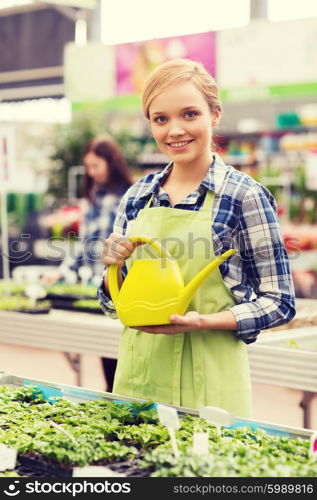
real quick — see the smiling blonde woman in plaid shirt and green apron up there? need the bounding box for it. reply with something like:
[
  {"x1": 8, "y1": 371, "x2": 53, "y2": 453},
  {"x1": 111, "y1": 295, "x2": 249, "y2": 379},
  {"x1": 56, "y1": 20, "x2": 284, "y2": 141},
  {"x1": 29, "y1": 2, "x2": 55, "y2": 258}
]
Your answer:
[{"x1": 98, "y1": 59, "x2": 295, "y2": 417}]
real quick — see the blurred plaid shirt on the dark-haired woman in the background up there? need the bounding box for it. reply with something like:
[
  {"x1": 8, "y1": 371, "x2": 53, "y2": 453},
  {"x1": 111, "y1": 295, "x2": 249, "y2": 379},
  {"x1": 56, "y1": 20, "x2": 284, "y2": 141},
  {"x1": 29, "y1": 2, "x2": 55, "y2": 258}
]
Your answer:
[{"x1": 60, "y1": 188, "x2": 121, "y2": 282}]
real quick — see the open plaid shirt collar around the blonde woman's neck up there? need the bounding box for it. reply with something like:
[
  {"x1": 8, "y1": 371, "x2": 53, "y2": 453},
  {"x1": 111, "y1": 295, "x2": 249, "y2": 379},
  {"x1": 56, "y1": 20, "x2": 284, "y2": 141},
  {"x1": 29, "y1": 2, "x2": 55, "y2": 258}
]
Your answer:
[{"x1": 140, "y1": 153, "x2": 230, "y2": 198}]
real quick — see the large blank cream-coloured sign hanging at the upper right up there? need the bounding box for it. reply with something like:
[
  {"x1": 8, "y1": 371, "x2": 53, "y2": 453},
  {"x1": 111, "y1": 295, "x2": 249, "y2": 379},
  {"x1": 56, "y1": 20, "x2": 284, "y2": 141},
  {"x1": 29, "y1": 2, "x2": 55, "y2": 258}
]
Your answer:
[{"x1": 217, "y1": 19, "x2": 317, "y2": 95}]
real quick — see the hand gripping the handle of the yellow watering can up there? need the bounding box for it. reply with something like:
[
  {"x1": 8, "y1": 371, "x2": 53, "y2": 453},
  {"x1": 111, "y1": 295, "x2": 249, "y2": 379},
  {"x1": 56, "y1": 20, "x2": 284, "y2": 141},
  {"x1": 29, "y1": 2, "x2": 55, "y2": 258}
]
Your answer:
[{"x1": 101, "y1": 233, "x2": 140, "y2": 267}]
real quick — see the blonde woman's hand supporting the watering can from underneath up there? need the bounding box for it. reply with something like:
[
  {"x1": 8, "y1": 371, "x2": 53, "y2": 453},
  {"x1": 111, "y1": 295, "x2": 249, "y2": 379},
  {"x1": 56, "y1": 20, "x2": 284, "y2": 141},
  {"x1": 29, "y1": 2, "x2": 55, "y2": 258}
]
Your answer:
[{"x1": 134, "y1": 311, "x2": 202, "y2": 335}]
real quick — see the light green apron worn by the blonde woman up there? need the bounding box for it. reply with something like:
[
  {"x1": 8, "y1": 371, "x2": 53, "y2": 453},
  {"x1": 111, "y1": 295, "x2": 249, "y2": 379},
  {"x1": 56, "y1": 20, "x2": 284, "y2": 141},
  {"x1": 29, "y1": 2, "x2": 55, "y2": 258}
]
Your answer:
[{"x1": 113, "y1": 191, "x2": 251, "y2": 417}]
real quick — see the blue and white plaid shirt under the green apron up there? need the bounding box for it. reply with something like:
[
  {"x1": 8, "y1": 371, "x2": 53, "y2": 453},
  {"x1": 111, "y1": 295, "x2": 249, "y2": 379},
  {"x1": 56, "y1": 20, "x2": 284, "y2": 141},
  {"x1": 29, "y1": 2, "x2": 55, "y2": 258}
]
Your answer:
[{"x1": 98, "y1": 154, "x2": 295, "y2": 344}]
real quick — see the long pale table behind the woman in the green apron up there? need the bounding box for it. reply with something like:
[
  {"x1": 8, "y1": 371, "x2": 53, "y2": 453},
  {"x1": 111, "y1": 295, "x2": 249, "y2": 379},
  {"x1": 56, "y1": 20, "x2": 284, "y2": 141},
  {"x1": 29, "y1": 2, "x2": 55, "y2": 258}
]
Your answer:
[{"x1": 0, "y1": 301, "x2": 317, "y2": 428}]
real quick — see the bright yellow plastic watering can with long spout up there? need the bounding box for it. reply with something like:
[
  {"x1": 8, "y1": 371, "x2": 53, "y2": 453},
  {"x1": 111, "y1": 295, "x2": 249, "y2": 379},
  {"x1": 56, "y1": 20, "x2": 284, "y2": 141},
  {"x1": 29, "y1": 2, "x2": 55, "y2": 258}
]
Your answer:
[{"x1": 108, "y1": 236, "x2": 237, "y2": 326}]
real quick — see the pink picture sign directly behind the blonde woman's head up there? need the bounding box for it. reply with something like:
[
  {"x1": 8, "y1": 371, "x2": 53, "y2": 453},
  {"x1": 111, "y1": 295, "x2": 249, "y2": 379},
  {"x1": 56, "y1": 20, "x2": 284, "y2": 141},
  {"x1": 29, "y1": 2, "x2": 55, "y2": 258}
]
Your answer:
[{"x1": 115, "y1": 32, "x2": 216, "y2": 95}]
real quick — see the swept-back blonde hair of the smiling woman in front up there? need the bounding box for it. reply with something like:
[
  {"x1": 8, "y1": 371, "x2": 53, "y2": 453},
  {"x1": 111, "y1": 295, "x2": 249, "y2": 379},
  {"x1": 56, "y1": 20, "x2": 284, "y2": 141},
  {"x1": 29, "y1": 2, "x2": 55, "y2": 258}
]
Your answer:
[{"x1": 142, "y1": 59, "x2": 221, "y2": 119}]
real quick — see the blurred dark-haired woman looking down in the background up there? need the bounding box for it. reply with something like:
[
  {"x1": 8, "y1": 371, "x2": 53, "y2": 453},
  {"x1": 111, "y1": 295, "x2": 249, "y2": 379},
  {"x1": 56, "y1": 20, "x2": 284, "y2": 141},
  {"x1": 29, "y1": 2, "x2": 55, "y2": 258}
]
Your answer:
[{"x1": 42, "y1": 135, "x2": 132, "y2": 391}]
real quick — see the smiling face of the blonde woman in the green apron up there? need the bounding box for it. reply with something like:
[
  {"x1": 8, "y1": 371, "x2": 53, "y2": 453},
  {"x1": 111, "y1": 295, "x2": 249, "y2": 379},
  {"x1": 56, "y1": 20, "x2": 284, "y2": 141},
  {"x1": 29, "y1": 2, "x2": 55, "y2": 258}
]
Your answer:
[{"x1": 149, "y1": 81, "x2": 219, "y2": 168}]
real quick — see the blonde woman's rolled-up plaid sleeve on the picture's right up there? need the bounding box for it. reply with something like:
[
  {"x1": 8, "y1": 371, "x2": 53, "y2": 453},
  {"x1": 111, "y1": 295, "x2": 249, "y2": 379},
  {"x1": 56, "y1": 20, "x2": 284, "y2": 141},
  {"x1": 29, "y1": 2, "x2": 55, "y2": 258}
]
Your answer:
[{"x1": 230, "y1": 185, "x2": 296, "y2": 344}]
